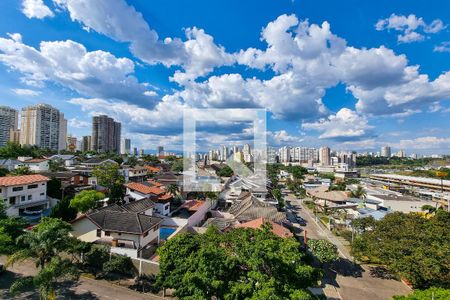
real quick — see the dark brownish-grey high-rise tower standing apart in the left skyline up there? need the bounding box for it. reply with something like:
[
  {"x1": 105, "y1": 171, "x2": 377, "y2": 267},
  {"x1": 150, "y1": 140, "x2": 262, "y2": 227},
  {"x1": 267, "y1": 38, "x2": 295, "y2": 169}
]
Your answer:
[{"x1": 91, "y1": 115, "x2": 121, "y2": 153}]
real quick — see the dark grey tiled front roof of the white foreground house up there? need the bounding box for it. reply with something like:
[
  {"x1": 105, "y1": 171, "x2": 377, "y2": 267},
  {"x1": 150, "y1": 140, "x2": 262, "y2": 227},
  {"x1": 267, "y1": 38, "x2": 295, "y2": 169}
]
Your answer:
[{"x1": 87, "y1": 209, "x2": 162, "y2": 234}]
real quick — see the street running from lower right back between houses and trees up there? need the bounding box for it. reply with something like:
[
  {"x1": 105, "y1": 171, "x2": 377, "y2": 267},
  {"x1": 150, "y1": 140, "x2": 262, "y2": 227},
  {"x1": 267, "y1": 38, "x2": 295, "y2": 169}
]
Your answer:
[{"x1": 286, "y1": 195, "x2": 411, "y2": 300}]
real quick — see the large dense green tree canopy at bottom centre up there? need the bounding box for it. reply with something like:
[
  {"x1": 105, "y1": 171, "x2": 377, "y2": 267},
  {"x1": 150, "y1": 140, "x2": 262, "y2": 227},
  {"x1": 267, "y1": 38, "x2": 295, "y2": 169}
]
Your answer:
[{"x1": 157, "y1": 224, "x2": 320, "y2": 299}]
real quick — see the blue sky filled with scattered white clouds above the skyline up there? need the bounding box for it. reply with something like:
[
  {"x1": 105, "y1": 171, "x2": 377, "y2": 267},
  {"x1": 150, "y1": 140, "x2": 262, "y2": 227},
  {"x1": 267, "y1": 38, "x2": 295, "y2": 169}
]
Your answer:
[{"x1": 0, "y1": 0, "x2": 450, "y2": 154}]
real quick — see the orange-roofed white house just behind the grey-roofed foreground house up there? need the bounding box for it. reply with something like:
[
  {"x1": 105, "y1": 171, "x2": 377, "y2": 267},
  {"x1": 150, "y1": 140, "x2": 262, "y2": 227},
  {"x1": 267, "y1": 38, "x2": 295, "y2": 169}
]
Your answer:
[{"x1": 125, "y1": 182, "x2": 172, "y2": 216}]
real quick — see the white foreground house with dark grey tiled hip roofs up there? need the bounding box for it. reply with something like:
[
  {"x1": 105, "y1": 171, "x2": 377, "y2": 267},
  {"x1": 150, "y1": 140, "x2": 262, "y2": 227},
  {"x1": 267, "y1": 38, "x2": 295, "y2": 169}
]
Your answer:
[{"x1": 71, "y1": 199, "x2": 163, "y2": 258}]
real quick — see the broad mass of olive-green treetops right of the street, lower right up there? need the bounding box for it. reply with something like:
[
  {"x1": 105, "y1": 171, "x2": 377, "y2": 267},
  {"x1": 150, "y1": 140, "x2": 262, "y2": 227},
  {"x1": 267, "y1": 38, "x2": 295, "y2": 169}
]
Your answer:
[{"x1": 352, "y1": 210, "x2": 450, "y2": 288}]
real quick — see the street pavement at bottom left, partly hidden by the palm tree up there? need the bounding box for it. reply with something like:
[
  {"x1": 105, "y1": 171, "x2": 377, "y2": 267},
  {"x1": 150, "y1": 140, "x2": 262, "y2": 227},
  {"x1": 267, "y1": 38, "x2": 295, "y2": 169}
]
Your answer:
[{"x1": 0, "y1": 256, "x2": 167, "y2": 300}]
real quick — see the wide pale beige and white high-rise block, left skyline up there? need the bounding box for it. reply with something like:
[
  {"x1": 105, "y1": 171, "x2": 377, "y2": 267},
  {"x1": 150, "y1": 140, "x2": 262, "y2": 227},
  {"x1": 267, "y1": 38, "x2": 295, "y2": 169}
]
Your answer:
[{"x1": 20, "y1": 104, "x2": 67, "y2": 150}]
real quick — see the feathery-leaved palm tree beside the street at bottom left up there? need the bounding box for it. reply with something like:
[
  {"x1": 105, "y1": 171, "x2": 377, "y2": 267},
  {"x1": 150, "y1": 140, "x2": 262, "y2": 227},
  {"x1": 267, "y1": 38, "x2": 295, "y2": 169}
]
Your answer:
[{"x1": 7, "y1": 217, "x2": 78, "y2": 299}]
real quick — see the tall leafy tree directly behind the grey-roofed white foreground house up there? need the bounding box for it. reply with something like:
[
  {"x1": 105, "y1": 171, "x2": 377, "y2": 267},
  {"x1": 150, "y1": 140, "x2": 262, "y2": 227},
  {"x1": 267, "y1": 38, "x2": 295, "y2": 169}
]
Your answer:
[{"x1": 92, "y1": 163, "x2": 125, "y2": 203}]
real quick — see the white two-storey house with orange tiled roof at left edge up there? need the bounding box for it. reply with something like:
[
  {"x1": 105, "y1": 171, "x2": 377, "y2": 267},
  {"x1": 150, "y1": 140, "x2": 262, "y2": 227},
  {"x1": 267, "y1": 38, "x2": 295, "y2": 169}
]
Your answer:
[{"x1": 0, "y1": 174, "x2": 50, "y2": 216}]
